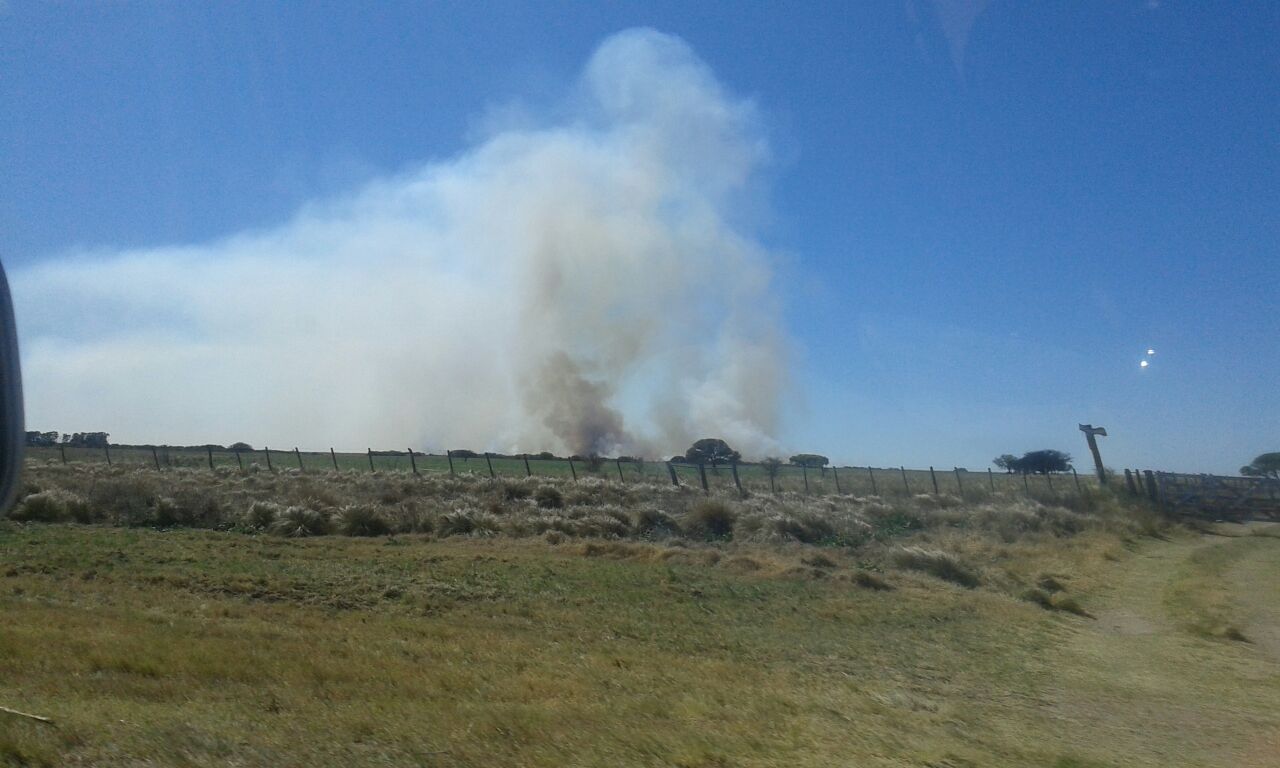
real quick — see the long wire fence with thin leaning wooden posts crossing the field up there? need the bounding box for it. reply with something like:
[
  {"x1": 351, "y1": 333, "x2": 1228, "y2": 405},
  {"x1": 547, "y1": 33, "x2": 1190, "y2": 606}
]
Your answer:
[{"x1": 27, "y1": 444, "x2": 1128, "y2": 499}]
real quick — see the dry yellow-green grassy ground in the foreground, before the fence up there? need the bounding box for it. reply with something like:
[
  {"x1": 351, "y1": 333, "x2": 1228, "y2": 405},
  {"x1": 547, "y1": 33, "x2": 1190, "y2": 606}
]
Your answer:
[{"x1": 0, "y1": 458, "x2": 1280, "y2": 768}]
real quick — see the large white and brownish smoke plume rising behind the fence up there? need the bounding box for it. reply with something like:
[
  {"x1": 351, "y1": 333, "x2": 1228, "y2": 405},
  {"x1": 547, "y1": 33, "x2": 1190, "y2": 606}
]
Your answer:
[{"x1": 13, "y1": 29, "x2": 786, "y2": 456}]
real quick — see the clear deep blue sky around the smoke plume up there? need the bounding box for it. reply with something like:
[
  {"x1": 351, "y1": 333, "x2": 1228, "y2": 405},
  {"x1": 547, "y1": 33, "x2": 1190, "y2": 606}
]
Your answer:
[{"x1": 0, "y1": 0, "x2": 1280, "y2": 471}]
